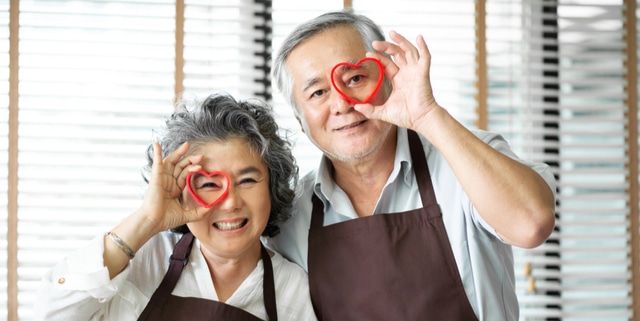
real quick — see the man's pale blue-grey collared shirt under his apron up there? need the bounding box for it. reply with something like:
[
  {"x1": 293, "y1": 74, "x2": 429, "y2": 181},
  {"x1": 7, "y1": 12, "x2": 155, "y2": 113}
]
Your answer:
[{"x1": 267, "y1": 128, "x2": 555, "y2": 321}]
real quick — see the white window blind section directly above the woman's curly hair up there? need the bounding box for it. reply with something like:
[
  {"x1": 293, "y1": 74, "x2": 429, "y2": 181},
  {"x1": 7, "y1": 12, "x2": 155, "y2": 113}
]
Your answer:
[{"x1": 184, "y1": 0, "x2": 265, "y2": 99}]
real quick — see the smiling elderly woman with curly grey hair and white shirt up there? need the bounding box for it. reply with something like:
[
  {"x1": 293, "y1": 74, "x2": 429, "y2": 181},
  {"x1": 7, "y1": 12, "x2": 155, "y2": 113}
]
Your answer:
[{"x1": 35, "y1": 94, "x2": 316, "y2": 321}]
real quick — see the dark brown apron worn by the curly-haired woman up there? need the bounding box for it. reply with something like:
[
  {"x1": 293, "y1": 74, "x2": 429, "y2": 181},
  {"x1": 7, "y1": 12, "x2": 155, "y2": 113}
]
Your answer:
[{"x1": 138, "y1": 233, "x2": 278, "y2": 321}]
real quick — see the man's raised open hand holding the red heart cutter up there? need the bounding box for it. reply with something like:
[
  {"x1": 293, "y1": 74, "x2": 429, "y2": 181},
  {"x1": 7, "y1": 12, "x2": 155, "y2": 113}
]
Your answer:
[{"x1": 355, "y1": 31, "x2": 441, "y2": 130}]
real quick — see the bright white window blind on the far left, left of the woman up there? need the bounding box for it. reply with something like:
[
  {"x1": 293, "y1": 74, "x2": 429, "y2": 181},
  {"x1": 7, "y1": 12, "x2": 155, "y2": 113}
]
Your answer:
[{"x1": 18, "y1": 0, "x2": 175, "y2": 320}]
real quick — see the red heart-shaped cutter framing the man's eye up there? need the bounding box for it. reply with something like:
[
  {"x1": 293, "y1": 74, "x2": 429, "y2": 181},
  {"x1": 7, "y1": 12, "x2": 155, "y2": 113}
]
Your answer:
[{"x1": 331, "y1": 57, "x2": 384, "y2": 104}]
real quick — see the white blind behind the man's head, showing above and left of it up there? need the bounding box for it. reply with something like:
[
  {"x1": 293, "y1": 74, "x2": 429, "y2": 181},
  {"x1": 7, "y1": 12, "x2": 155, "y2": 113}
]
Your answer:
[{"x1": 272, "y1": 0, "x2": 343, "y2": 176}]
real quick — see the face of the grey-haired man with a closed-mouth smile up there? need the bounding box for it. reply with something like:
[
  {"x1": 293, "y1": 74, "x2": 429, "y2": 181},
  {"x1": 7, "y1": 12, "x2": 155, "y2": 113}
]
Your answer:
[{"x1": 286, "y1": 26, "x2": 393, "y2": 162}]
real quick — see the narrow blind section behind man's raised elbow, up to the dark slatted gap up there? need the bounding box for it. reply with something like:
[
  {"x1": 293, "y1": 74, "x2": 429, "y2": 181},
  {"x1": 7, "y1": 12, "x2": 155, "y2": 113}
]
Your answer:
[{"x1": 486, "y1": 0, "x2": 560, "y2": 320}]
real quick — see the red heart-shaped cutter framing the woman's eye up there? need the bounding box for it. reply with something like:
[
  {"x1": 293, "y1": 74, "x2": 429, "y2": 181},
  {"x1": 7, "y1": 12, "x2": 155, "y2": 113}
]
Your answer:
[{"x1": 186, "y1": 170, "x2": 231, "y2": 208}]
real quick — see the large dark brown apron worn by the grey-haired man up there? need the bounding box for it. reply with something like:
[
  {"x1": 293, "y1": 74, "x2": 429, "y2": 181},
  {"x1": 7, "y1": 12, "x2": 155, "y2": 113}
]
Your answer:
[{"x1": 308, "y1": 131, "x2": 478, "y2": 321}]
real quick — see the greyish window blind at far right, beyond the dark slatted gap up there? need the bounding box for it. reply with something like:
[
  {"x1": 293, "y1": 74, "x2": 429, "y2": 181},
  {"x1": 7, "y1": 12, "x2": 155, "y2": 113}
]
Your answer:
[{"x1": 558, "y1": 0, "x2": 632, "y2": 320}]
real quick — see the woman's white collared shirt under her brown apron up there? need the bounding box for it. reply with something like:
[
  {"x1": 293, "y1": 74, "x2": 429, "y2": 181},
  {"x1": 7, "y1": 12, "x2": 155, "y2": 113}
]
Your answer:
[{"x1": 34, "y1": 232, "x2": 316, "y2": 321}]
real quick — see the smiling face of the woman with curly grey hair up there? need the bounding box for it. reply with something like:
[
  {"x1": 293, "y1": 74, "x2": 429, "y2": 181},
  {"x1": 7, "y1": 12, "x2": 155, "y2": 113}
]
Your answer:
[{"x1": 182, "y1": 138, "x2": 271, "y2": 258}]
